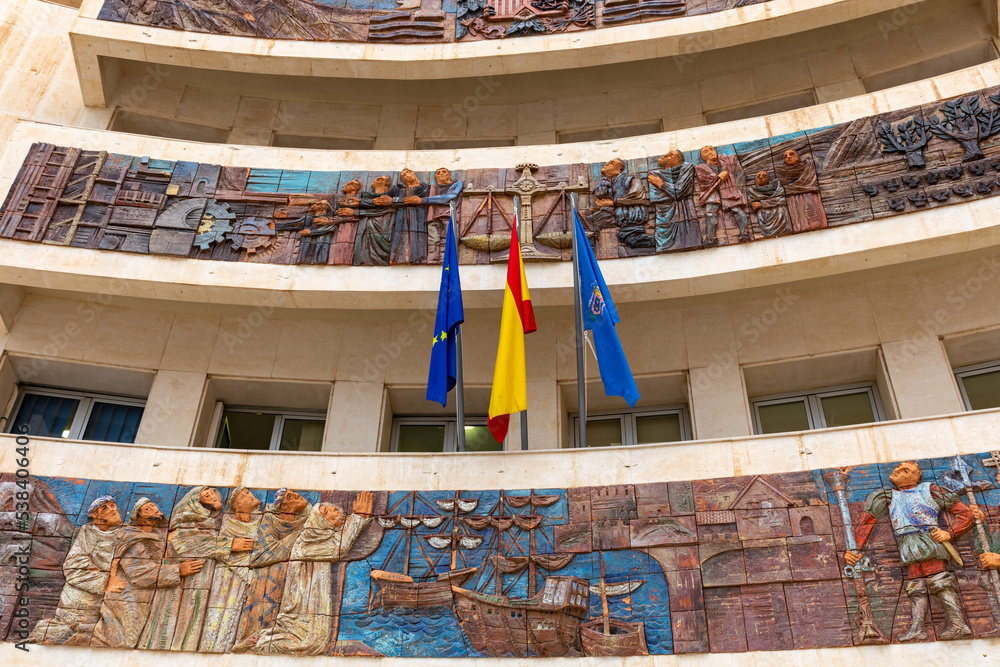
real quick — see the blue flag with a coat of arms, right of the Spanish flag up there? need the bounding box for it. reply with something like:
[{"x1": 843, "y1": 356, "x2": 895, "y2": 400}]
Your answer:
[{"x1": 573, "y1": 210, "x2": 639, "y2": 407}]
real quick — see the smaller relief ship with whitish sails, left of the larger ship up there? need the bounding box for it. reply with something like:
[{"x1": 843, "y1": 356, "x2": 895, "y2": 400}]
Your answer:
[{"x1": 369, "y1": 491, "x2": 483, "y2": 609}]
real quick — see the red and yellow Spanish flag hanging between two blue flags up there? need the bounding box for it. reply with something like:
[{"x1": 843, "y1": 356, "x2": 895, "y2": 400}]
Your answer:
[{"x1": 489, "y1": 214, "x2": 537, "y2": 442}]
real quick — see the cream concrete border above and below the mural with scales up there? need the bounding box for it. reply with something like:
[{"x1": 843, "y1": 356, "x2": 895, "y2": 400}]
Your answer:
[{"x1": 0, "y1": 61, "x2": 1000, "y2": 309}]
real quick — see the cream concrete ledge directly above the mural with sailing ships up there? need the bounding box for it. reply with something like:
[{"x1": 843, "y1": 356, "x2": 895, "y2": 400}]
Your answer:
[{"x1": 0, "y1": 409, "x2": 1000, "y2": 491}]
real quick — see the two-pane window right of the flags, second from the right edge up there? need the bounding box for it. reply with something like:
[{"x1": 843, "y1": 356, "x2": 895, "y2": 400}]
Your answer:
[{"x1": 753, "y1": 384, "x2": 885, "y2": 434}]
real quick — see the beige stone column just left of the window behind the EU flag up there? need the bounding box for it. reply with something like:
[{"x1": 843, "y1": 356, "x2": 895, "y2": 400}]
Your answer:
[{"x1": 323, "y1": 380, "x2": 384, "y2": 453}]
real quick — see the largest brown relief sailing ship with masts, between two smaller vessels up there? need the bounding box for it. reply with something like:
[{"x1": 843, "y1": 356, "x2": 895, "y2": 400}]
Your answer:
[{"x1": 452, "y1": 491, "x2": 590, "y2": 658}]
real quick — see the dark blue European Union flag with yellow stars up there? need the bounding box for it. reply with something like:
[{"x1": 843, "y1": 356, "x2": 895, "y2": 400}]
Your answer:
[{"x1": 427, "y1": 218, "x2": 465, "y2": 406}]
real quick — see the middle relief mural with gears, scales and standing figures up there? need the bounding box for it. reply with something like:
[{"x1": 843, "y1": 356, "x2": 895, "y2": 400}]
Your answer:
[{"x1": 0, "y1": 89, "x2": 1000, "y2": 266}]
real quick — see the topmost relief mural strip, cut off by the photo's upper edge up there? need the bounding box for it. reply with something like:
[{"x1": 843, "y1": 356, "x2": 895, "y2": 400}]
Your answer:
[{"x1": 98, "y1": 0, "x2": 767, "y2": 43}]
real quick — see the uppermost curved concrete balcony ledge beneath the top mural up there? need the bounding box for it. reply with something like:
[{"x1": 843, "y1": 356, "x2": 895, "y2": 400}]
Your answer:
[{"x1": 70, "y1": 0, "x2": 919, "y2": 106}]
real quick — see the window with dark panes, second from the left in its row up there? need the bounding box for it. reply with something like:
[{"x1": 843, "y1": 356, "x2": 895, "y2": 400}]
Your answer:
[{"x1": 215, "y1": 408, "x2": 326, "y2": 452}]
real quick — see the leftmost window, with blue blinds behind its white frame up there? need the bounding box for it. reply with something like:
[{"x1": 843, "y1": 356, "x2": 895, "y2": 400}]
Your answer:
[{"x1": 10, "y1": 387, "x2": 146, "y2": 442}]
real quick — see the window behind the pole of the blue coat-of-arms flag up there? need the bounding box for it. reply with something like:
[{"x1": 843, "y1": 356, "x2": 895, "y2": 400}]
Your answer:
[{"x1": 572, "y1": 408, "x2": 691, "y2": 447}]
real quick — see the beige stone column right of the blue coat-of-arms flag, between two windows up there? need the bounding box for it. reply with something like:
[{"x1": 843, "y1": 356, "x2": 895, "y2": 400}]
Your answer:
[{"x1": 690, "y1": 364, "x2": 753, "y2": 440}]
